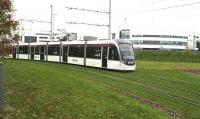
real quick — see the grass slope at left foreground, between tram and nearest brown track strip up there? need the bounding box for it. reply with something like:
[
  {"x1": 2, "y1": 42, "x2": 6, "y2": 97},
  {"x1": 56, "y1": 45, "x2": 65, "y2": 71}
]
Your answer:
[{"x1": 2, "y1": 60, "x2": 171, "y2": 119}]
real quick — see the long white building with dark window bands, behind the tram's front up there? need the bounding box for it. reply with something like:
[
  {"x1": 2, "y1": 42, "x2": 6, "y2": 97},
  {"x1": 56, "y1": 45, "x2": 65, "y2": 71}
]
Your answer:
[{"x1": 120, "y1": 29, "x2": 199, "y2": 50}]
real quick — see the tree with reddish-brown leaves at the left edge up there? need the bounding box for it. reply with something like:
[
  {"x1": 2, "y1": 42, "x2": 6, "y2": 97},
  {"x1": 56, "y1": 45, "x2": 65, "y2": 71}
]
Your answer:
[{"x1": 0, "y1": 0, "x2": 20, "y2": 60}]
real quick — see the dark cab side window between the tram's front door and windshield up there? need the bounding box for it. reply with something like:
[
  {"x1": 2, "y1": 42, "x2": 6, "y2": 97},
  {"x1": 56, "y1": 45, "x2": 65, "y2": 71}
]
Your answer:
[{"x1": 109, "y1": 46, "x2": 119, "y2": 60}]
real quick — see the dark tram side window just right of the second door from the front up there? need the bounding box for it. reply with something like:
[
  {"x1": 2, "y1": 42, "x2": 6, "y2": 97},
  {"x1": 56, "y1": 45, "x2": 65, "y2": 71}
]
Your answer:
[{"x1": 69, "y1": 46, "x2": 84, "y2": 57}]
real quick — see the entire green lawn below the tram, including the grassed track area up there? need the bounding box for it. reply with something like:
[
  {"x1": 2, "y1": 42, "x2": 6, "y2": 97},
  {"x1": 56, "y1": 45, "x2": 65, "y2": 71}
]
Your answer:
[{"x1": 2, "y1": 60, "x2": 200, "y2": 119}]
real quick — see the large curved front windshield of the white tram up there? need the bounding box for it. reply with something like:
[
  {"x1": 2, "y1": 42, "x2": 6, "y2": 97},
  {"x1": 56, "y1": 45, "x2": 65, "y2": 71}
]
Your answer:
[{"x1": 119, "y1": 44, "x2": 134, "y2": 61}]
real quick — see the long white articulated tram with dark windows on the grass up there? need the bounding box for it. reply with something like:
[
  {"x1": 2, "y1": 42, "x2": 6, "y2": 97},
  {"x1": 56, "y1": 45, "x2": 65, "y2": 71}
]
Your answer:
[{"x1": 11, "y1": 40, "x2": 136, "y2": 71}]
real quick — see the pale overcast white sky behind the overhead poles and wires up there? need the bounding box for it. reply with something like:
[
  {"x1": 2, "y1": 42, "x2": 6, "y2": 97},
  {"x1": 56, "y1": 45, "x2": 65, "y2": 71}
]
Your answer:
[{"x1": 14, "y1": 0, "x2": 200, "y2": 38}]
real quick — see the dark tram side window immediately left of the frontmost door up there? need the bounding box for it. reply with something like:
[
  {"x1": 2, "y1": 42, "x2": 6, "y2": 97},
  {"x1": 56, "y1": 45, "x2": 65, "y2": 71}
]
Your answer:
[{"x1": 86, "y1": 47, "x2": 101, "y2": 59}]
